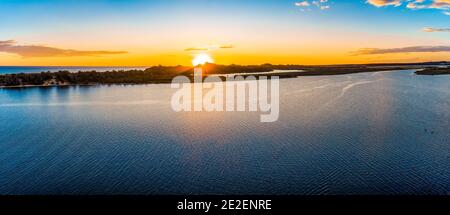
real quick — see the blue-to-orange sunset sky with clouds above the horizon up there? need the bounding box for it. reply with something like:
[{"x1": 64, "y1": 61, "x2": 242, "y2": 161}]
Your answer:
[{"x1": 0, "y1": 0, "x2": 450, "y2": 66}]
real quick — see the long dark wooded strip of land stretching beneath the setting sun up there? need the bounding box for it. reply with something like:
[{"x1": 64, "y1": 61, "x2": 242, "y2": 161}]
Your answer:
[{"x1": 0, "y1": 62, "x2": 450, "y2": 88}]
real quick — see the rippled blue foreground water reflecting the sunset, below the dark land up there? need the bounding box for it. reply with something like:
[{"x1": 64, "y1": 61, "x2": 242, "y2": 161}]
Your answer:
[{"x1": 0, "y1": 71, "x2": 450, "y2": 194}]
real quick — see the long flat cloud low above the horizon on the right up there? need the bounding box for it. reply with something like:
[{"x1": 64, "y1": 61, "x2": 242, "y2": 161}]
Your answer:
[{"x1": 352, "y1": 46, "x2": 450, "y2": 55}]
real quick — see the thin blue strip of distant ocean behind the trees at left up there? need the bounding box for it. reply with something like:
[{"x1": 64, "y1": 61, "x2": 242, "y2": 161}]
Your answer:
[{"x1": 0, "y1": 66, "x2": 148, "y2": 74}]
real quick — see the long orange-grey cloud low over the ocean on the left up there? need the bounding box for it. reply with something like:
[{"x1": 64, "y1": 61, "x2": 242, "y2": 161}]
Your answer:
[{"x1": 0, "y1": 40, "x2": 127, "y2": 57}]
